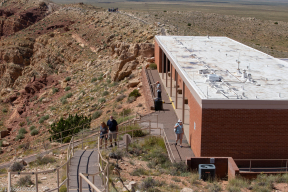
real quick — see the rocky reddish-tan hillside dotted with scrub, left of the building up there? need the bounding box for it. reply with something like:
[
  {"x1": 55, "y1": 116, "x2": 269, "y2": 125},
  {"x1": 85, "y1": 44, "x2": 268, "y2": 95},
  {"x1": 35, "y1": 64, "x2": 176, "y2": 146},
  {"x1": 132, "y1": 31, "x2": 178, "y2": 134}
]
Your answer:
[{"x1": 0, "y1": 1, "x2": 160, "y2": 160}]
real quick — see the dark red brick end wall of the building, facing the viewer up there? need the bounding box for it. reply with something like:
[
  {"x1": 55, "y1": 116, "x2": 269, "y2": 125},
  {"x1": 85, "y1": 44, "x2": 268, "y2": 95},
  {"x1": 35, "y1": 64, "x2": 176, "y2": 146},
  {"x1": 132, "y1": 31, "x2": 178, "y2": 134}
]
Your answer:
[{"x1": 201, "y1": 109, "x2": 288, "y2": 159}]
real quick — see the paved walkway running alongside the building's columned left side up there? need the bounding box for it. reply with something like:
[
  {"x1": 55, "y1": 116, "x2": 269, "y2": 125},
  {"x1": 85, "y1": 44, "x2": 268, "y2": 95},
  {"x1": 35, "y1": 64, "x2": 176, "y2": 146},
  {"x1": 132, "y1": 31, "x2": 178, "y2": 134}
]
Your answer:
[{"x1": 142, "y1": 70, "x2": 195, "y2": 162}]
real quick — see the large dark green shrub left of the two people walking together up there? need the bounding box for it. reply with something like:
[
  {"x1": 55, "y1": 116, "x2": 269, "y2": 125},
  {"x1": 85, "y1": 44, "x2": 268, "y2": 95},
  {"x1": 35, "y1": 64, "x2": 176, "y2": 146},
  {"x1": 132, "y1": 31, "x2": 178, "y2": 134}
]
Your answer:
[{"x1": 49, "y1": 114, "x2": 91, "y2": 140}]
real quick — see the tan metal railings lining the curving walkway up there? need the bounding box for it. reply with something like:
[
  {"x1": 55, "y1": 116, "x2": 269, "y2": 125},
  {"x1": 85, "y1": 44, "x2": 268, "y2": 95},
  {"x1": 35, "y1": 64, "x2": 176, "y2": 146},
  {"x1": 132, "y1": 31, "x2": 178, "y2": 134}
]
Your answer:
[{"x1": 3, "y1": 114, "x2": 175, "y2": 192}]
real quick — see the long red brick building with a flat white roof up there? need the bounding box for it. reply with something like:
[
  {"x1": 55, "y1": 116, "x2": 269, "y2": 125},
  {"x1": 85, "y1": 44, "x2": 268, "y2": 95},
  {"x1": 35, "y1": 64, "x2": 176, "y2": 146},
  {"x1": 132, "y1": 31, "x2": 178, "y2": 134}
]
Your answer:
[{"x1": 155, "y1": 36, "x2": 288, "y2": 159}]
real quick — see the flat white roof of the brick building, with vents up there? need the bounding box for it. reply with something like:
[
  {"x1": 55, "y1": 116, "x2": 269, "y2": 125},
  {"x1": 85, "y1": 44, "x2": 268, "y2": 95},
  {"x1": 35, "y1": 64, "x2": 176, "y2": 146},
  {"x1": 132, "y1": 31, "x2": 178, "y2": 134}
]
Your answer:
[{"x1": 156, "y1": 36, "x2": 288, "y2": 100}]
